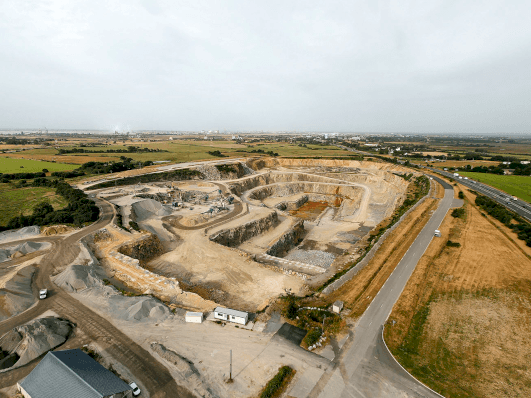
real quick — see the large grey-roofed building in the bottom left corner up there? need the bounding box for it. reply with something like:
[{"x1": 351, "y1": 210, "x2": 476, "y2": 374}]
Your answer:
[{"x1": 18, "y1": 349, "x2": 132, "y2": 398}]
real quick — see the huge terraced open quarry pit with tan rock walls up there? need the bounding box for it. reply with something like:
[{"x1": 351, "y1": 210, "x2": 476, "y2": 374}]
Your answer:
[{"x1": 90, "y1": 158, "x2": 408, "y2": 312}]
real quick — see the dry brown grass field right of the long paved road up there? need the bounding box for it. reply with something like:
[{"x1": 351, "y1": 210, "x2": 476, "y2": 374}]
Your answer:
[{"x1": 385, "y1": 190, "x2": 531, "y2": 398}]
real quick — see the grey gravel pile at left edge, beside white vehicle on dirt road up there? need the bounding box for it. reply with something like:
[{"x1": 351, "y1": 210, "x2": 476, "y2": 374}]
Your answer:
[{"x1": 0, "y1": 265, "x2": 35, "y2": 321}]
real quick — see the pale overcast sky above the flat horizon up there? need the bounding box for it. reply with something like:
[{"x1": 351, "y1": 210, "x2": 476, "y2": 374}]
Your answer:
[{"x1": 0, "y1": 0, "x2": 531, "y2": 133}]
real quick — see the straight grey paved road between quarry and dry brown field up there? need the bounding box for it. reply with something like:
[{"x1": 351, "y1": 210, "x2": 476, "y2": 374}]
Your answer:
[{"x1": 309, "y1": 177, "x2": 454, "y2": 398}]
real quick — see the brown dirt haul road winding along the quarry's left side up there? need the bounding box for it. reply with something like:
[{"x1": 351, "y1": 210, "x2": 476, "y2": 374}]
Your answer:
[{"x1": 0, "y1": 201, "x2": 193, "y2": 398}]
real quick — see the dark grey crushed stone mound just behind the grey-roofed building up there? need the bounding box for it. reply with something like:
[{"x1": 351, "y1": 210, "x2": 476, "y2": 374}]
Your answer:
[{"x1": 0, "y1": 316, "x2": 73, "y2": 369}]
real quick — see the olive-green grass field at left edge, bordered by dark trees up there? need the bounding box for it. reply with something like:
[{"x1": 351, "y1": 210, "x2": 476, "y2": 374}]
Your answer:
[{"x1": 0, "y1": 184, "x2": 68, "y2": 225}]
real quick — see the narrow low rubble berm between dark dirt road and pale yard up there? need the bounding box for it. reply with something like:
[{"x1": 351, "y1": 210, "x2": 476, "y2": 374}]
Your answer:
[{"x1": 151, "y1": 343, "x2": 218, "y2": 398}]
